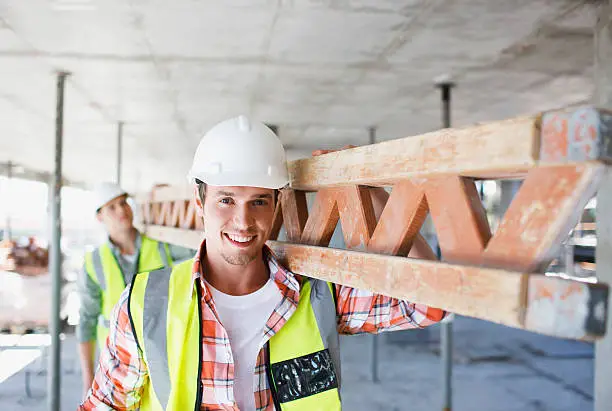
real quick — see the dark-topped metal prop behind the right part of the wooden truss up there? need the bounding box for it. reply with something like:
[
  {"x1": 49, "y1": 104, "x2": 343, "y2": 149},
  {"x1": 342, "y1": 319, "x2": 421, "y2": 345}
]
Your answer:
[{"x1": 436, "y1": 79, "x2": 455, "y2": 411}]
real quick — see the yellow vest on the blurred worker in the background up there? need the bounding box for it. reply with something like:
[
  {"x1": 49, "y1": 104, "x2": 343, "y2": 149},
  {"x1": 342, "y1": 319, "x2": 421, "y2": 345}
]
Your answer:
[{"x1": 85, "y1": 235, "x2": 172, "y2": 348}]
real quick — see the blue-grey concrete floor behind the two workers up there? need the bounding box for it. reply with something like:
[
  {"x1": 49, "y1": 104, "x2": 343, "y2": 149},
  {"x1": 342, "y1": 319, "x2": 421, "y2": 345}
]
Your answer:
[{"x1": 0, "y1": 317, "x2": 593, "y2": 411}]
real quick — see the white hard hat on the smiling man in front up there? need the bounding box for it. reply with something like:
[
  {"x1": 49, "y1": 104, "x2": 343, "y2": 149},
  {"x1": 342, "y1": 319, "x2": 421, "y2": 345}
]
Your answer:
[{"x1": 189, "y1": 116, "x2": 289, "y2": 189}]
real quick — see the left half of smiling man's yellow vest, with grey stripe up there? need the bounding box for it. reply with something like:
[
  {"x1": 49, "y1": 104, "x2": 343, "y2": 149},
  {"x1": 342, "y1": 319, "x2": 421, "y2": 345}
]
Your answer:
[{"x1": 128, "y1": 259, "x2": 202, "y2": 411}]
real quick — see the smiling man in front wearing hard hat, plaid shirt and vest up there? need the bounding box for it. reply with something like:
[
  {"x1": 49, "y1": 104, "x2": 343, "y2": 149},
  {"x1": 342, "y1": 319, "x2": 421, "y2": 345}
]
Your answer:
[{"x1": 79, "y1": 116, "x2": 445, "y2": 411}]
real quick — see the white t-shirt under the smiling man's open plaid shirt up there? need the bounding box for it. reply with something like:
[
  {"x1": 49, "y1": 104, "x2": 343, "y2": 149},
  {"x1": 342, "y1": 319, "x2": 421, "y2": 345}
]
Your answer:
[{"x1": 207, "y1": 279, "x2": 283, "y2": 411}]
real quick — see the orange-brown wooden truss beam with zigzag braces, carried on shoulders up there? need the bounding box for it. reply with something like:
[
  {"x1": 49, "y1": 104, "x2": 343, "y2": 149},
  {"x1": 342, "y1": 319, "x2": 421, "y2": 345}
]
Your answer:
[{"x1": 139, "y1": 107, "x2": 612, "y2": 339}]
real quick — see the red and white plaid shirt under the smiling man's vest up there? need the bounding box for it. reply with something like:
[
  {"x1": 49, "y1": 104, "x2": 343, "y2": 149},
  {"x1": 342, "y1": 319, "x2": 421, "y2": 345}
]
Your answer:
[{"x1": 79, "y1": 243, "x2": 445, "y2": 411}]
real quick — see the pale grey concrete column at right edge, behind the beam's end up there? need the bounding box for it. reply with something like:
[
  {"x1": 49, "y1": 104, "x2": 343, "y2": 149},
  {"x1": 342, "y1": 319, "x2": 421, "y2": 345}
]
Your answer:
[{"x1": 594, "y1": 0, "x2": 612, "y2": 411}]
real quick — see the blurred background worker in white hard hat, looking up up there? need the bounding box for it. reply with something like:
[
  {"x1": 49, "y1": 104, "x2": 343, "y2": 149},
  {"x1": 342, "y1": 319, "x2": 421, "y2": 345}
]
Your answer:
[{"x1": 77, "y1": 183, "x2": 195, "y2": 393}]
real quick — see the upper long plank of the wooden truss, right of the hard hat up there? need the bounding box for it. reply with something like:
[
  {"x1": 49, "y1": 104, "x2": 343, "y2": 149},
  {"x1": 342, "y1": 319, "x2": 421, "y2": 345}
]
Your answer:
[{"x1": 289, "y1": 107, "x2": 612, "y2": 190}]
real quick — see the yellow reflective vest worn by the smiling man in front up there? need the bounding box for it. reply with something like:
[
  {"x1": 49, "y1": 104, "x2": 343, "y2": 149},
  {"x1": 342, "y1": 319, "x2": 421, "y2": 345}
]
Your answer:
[{"x1": 128, "y1": 260, "x2": 341, "y2": 411}]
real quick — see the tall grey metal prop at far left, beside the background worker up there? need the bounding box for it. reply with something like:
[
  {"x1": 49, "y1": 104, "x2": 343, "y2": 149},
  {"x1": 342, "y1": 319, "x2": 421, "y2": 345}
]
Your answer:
[{"x1": 47, "y1": 72, "x2": 68, "y2": 411}]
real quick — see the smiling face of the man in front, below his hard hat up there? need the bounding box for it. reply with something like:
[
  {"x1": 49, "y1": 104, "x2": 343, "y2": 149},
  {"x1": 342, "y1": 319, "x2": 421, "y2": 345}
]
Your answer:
[{"x1": 203, "y1": 185, "x2": 275, "y2": 265}]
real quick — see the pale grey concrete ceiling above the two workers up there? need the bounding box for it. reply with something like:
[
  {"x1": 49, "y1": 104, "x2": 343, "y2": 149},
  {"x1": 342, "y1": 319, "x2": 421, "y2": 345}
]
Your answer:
[{"x1": 0, "y1": 0, "x2": 595, "y2": 189}]
